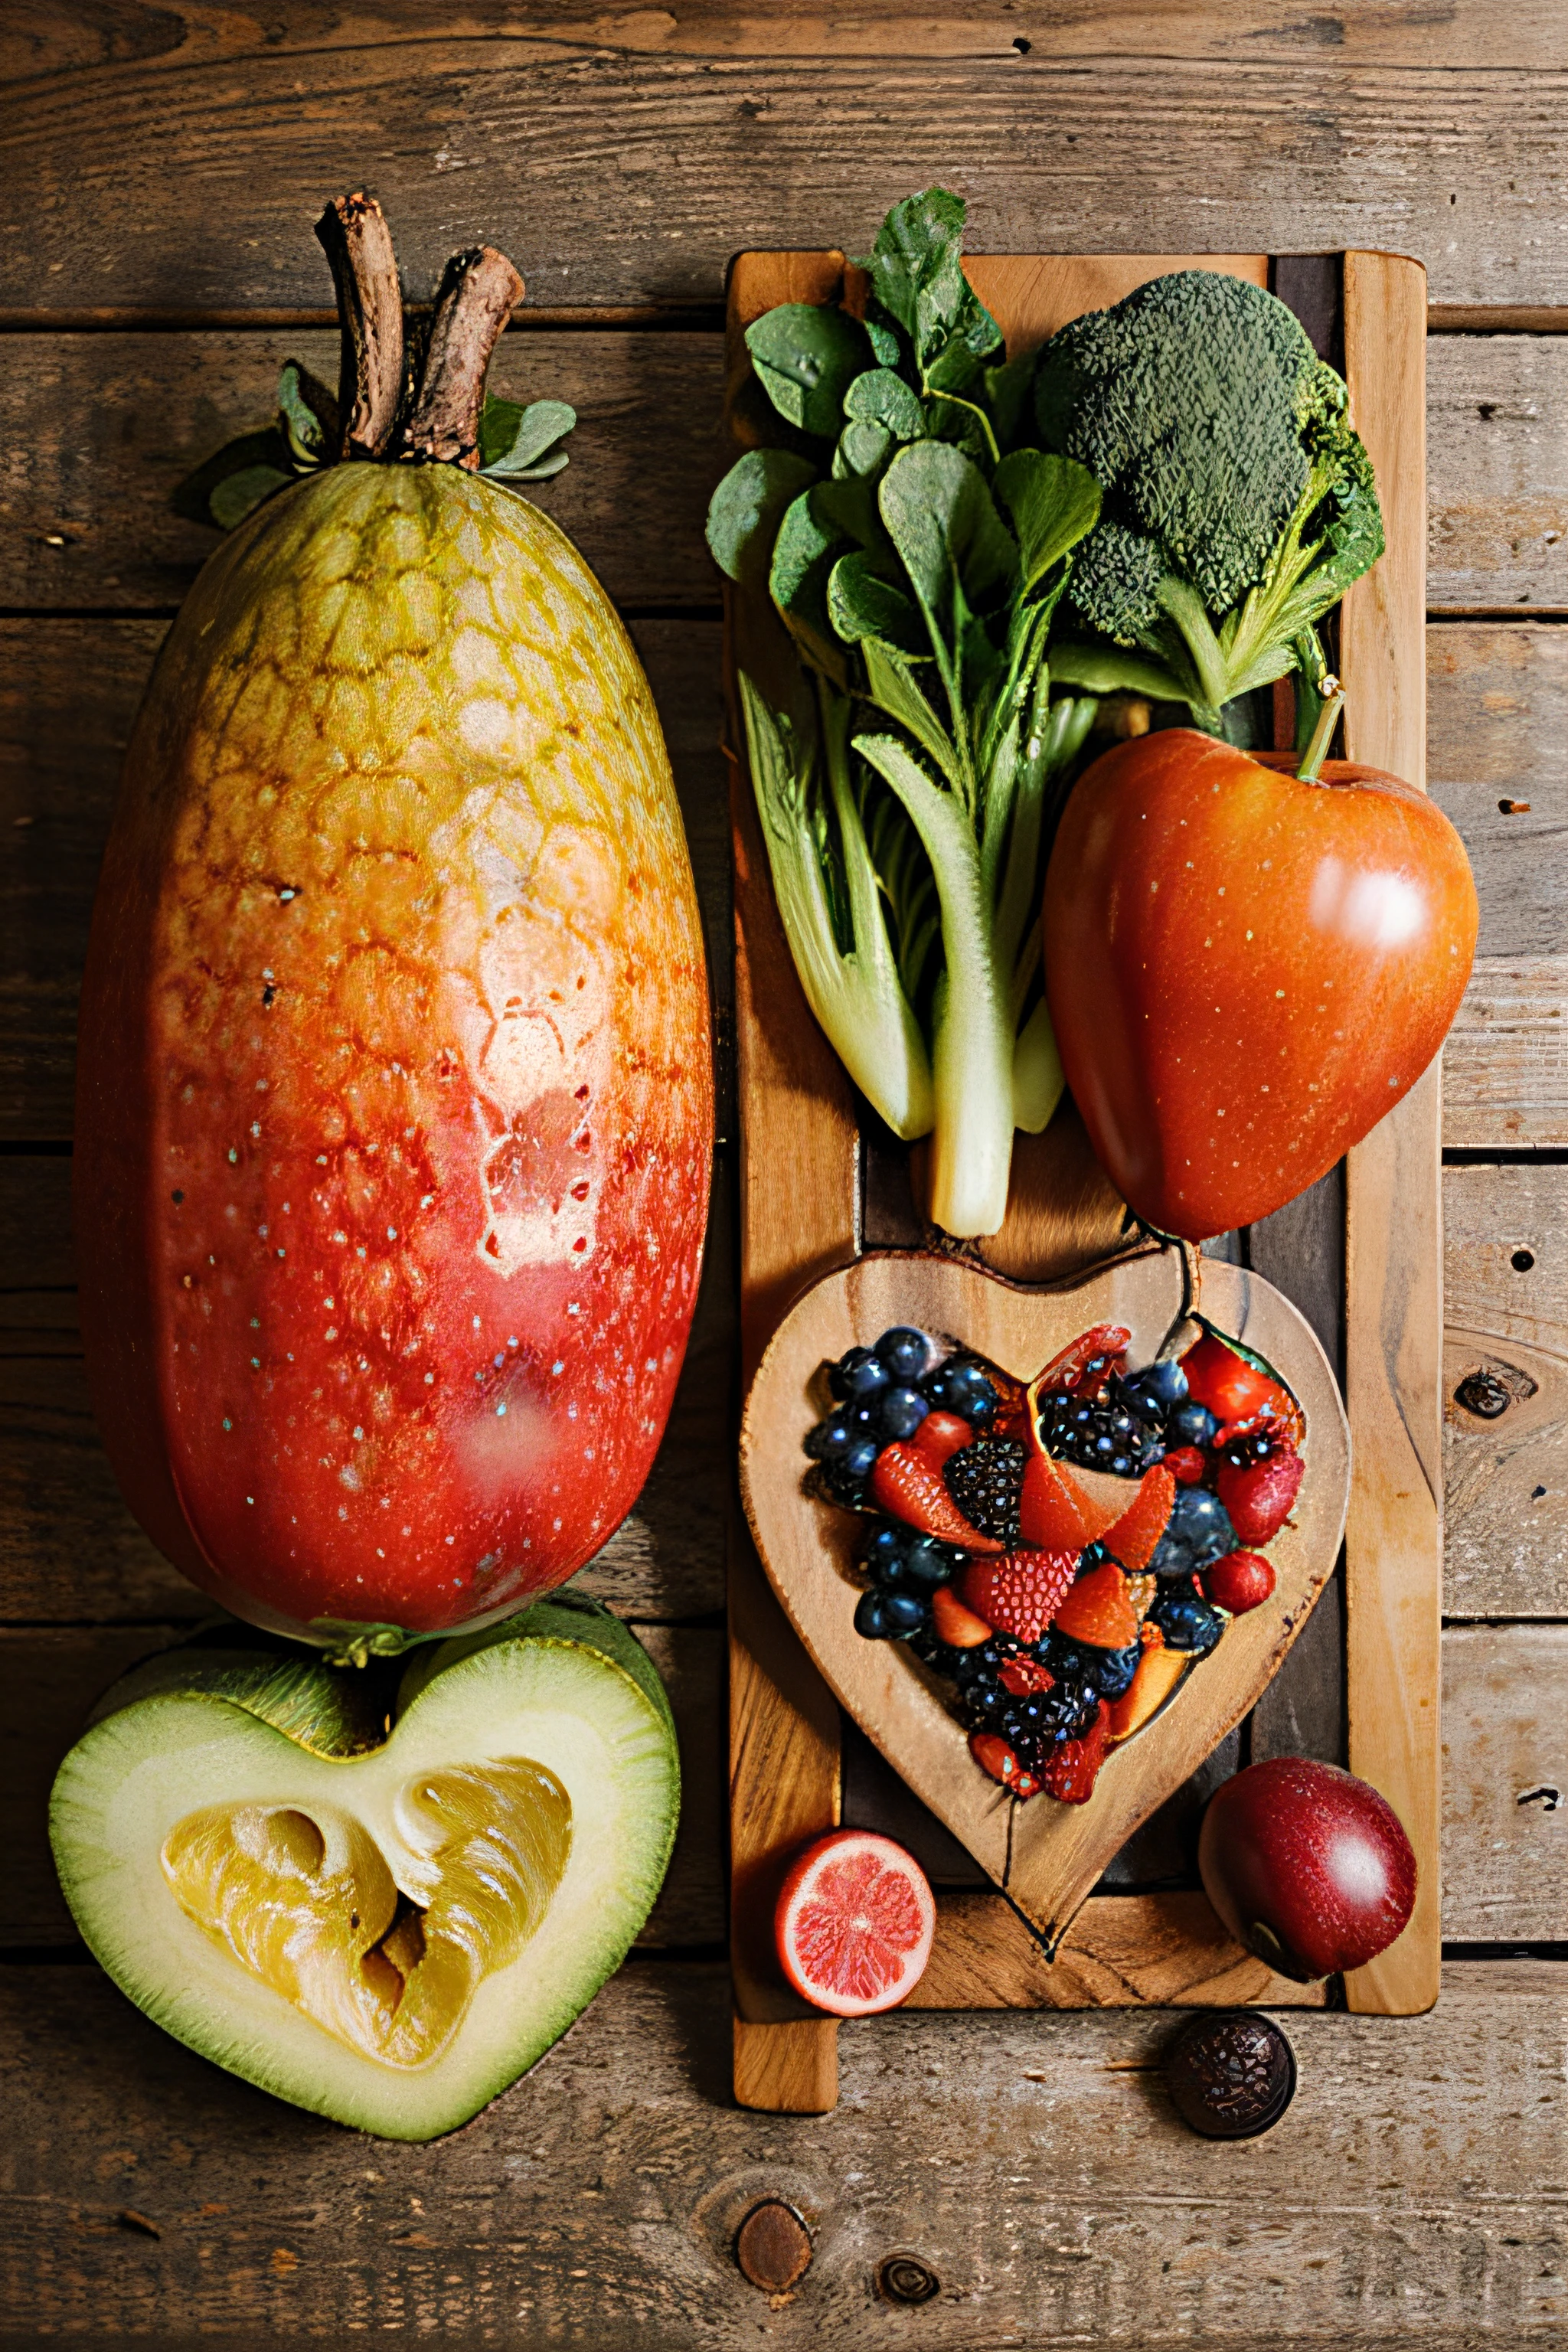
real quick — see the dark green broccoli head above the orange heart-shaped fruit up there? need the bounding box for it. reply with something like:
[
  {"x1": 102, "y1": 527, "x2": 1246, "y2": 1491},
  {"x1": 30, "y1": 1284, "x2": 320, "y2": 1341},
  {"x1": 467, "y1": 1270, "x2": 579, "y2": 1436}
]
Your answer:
[{"x1": 1034, "y1": 270, "x2": 1382, "y2": 724}]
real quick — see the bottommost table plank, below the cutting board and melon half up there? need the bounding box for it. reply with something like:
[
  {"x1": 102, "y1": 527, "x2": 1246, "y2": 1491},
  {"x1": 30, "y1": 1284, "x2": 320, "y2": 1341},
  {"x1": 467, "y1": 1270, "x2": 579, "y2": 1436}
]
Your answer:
[{"x1": 0, "y1": 1962, "x2": 1568, "y2": 2352}]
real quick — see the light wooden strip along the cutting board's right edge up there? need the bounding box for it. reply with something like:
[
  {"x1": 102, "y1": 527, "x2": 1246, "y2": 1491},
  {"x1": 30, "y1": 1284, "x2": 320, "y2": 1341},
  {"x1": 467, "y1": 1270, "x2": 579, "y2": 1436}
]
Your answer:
[{"x1": 1340, "y1": 252, "x2": 1443, "y2": 2016}]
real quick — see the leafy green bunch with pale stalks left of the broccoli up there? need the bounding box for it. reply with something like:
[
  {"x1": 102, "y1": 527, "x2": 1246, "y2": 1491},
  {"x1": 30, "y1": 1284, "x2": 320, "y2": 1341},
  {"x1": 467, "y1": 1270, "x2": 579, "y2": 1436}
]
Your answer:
[{"x1": 707, "y1": 188, "x2": 1100, "y2": 1235}]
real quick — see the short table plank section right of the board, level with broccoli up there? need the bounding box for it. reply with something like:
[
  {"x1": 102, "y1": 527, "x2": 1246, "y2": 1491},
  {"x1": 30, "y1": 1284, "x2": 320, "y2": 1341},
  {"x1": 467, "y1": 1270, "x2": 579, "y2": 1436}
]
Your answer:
[{"x1": 1427, "y1": 343, "x2": 1568, "y2": 612}]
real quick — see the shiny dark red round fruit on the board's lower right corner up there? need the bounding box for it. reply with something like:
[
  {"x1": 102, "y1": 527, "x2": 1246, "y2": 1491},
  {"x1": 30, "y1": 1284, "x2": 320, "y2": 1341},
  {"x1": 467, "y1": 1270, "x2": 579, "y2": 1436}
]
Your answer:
[{"x1": 1204, "y1": 1759, "x2": 1415, "y2": 1985}]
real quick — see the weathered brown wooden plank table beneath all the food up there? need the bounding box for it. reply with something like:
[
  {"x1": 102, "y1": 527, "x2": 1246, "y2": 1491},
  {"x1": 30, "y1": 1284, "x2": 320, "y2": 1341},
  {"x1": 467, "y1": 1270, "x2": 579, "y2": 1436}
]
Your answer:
[{"x1": 0, "y1": 0, "x2": 1568, "y2": 2352}]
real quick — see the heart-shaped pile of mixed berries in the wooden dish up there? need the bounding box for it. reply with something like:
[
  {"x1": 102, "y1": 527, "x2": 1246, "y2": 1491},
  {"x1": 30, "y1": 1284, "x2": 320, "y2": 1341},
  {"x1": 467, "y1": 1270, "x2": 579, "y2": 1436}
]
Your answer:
[{"x1": 806, "y1": 1325, "x2": 1305, "y2": 1804}]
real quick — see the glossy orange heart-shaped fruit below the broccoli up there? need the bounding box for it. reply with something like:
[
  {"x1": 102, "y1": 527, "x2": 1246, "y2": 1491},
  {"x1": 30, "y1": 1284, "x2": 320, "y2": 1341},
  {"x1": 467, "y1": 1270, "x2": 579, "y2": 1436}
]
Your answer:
[{"x1": 1044, "y1": 727, "x2": 1478, "y2": 1240}]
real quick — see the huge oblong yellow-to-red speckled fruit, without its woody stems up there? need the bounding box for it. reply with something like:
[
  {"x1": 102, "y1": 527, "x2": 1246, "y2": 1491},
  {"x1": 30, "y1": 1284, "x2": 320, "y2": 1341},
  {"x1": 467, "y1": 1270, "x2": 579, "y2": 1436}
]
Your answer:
[{"x1": 75, "y1": 463, "x2": 712, "y2": 1632}]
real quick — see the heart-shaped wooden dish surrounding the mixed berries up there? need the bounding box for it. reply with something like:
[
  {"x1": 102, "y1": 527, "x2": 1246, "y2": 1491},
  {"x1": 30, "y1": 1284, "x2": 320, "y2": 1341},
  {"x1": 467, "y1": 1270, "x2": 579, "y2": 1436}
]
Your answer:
[{"x1": 740, "y1": 1244, "x2": 1349, "y2": 1955}]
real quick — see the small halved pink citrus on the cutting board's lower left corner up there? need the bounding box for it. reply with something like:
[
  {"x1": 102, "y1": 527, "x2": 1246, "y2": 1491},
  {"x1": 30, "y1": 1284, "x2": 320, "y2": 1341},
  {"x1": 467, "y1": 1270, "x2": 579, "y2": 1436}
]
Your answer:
[{"x1": 776, "y1": 1830, "x2": 936, "y2": 2018}]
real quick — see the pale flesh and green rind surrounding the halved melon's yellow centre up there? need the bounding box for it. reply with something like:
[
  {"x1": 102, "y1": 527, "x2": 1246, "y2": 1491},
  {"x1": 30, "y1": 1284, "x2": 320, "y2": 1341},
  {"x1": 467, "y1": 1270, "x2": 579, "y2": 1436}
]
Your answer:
[{"x1": 49, "y1": 1602, "x2": 679, "y2": 2141}]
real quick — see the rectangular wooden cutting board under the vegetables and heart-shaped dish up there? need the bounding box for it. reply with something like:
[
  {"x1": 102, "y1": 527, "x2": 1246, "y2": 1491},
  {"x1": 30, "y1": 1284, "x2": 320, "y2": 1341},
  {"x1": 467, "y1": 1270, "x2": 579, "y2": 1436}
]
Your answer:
[{"x1": 727, "y1": 238, "x2": 1441, "y2": 2112}]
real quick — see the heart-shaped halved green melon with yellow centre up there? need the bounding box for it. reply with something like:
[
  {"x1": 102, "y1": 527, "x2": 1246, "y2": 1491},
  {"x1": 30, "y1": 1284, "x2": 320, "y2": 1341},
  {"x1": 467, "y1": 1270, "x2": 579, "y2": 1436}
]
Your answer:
[{"x1": 49, "y1": 1597, "x2": 679, "y2": 2141}]
